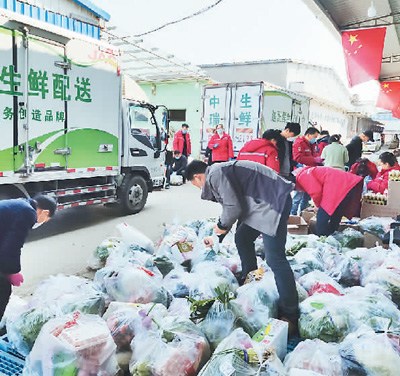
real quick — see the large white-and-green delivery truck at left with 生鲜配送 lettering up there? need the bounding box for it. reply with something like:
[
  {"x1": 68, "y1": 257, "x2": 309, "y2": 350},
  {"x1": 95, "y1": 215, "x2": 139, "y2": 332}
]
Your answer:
[{"x1": 0, "y1": 15, "x2": 168, "y2": 214}]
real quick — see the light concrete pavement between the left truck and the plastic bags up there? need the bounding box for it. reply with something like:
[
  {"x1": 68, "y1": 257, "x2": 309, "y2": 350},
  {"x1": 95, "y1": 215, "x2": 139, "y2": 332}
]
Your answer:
[{"x1": 14, "y1": 183, "x2": 220, "y2": 296}]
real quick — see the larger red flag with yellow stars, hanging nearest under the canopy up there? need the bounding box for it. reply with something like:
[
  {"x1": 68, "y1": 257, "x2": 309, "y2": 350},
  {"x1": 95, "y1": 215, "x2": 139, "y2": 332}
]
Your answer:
[{"x1": 342, "y1": 27, "x2": 386, "y2": 86}]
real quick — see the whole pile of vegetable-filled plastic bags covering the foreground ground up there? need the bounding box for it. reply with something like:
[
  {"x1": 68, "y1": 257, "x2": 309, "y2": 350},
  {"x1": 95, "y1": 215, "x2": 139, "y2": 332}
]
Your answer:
[{"x1": 3, "y1": 218, "x2": 400, "y2": 376}]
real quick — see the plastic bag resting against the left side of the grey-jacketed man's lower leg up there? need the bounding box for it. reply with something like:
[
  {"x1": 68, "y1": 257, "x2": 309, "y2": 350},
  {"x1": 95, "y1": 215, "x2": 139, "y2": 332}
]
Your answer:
[{"x1": 230, "y1": 273, "x2": 279, "y2": 336}]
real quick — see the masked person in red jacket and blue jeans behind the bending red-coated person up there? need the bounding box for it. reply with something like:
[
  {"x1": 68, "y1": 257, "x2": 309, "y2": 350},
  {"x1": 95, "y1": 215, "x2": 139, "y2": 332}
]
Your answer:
[{"x1": 290, "y1": 127, "x2": 322, "y2": 215}]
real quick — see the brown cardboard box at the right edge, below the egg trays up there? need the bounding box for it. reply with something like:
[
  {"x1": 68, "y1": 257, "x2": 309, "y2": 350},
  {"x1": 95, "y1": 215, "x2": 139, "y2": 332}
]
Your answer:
[{"x1": 361, "y1": 180, "x2": 400, "y2": 218}]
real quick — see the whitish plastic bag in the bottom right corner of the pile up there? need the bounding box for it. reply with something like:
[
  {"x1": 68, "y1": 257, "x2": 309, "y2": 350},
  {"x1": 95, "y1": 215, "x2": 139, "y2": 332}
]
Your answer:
[{"x1": 339, "y1": 328, "x2": 400, "y2": 376}]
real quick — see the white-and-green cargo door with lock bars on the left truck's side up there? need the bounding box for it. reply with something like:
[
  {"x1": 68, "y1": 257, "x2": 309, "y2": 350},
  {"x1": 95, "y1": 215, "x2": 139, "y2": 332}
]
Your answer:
[{"x1": 13, "y1": 30, "x2": 70, "y2": 173}]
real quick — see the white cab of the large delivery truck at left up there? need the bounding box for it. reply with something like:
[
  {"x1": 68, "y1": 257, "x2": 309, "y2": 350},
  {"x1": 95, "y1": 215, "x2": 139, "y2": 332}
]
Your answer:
[{"x1": 128, "y1": 103, "x2": 165, "y2": 186}]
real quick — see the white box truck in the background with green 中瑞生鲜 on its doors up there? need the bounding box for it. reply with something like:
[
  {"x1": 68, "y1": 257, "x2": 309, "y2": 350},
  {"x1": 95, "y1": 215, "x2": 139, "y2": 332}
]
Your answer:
[{"x1": 201, "y1": 82, "x2": 310, "y2": 153}]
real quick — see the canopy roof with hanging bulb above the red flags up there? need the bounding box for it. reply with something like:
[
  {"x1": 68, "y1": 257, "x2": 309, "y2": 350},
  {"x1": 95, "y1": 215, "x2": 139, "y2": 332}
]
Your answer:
[{"x1": 303, "y1": 0, "x2": 400, "y2": 81}]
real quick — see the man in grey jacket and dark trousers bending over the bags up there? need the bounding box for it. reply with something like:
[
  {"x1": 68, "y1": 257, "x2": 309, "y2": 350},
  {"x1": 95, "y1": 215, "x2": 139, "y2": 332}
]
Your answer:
[{"x1": 186, "y1": 160, "x2": 299, "y2": 330}]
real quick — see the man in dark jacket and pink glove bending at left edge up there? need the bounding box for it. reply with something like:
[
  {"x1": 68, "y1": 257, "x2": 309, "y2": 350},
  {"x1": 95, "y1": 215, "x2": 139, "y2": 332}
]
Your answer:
[{"x1": 0, "y1": 195, "x2": 56, "y2": 320}]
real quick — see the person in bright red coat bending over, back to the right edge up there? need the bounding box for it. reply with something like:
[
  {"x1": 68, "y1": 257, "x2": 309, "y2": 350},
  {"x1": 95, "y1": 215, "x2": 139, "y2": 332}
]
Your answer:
[{"x1": 293, "y1": 167, "x2": 364, "y2": 236}]
